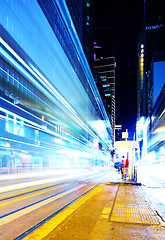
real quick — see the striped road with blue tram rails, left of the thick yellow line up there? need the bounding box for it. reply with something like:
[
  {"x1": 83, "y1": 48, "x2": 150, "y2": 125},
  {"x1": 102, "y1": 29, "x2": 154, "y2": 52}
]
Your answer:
[{"x1": 0, "y1": 169, "x2": 110, "y2": 240}]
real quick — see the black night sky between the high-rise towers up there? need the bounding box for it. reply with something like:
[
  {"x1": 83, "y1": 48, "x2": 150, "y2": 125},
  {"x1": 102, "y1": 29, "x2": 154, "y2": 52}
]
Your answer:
[{"x1": 94, "y1": 0, "x2": 143, "y2": 136}]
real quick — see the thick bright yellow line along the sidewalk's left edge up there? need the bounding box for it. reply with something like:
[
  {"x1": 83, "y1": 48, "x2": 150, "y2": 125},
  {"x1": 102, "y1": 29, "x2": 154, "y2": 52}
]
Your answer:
[{"x1": 23, "y1": 185, "x2": 104, "y2": 240}]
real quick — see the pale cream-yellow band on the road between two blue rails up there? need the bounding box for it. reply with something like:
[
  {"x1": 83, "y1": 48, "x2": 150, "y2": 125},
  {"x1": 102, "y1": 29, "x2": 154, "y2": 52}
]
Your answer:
[{"x1": 0, "y1": 184, "x2": 86, "y2": 226}]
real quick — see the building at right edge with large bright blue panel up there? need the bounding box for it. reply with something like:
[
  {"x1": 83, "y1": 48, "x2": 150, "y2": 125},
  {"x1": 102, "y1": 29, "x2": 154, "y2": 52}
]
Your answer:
[{"x1": 147, "y1": 50, "x2": 165, "y2": 156}]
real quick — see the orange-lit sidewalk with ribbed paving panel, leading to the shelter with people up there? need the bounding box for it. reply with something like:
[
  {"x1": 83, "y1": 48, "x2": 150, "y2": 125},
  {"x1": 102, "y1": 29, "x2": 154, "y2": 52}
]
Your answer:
[{"x1": 27, "y1": 183, "x2": 165, "y2": 240}]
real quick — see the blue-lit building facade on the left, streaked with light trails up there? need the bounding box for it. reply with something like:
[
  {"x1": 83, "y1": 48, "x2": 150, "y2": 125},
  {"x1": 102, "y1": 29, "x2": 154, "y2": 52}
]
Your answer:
[{"x1": 0, "y1": 0, "x2": 112, "y2": 171}]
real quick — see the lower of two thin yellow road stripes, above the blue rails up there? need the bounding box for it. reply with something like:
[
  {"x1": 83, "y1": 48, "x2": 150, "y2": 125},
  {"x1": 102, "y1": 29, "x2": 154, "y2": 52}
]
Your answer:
[{"x1": 0, "y1": 184, "x2": 69, "y2": 207}]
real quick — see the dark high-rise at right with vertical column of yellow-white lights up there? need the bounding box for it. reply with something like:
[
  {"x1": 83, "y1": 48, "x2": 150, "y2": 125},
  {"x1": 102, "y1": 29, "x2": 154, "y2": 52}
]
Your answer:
[{"x1": 138, "y1": 0, "x2": 165, "y2": 118}]
